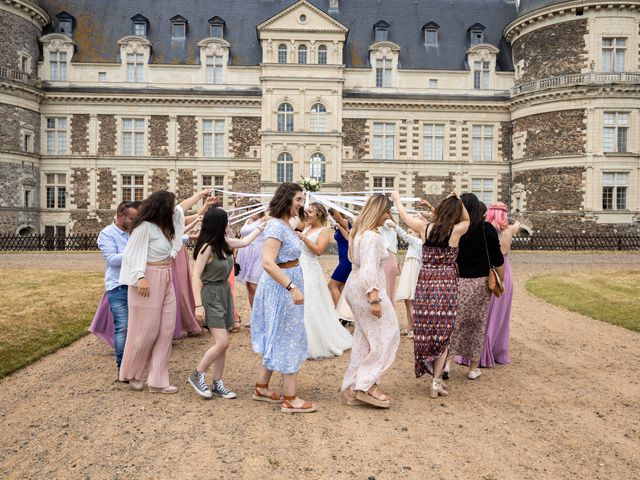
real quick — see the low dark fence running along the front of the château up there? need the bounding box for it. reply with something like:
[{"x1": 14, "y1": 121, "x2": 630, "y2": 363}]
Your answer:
[{"x1": 0, "y1": 233, "x2": 640, "y2": 253}]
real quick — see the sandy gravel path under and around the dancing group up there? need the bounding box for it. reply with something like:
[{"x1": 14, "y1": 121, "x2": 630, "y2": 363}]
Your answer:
[{"x1": 0, "y1": 252, "x2": 640, "y2": 480}]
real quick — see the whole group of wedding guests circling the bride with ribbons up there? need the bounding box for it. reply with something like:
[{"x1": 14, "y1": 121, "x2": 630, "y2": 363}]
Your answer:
[{"x1": 92, "y1": 183, "x2": 516, "y2": 413}]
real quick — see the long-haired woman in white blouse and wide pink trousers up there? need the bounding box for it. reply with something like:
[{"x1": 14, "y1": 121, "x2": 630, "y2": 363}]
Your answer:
[{"x1": 120, "y1": 190, "x2": 209, "y2": 393}]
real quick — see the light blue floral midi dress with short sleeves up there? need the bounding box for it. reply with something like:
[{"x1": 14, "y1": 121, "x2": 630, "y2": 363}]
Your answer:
[{"x1": 251, "y1": 218, "x2": 309, "y2": 374}]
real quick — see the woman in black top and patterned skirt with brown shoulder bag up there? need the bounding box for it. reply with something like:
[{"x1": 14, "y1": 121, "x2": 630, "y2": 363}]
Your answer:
[{"x1": 450, "y1": 193, "x2": 504, "y2": 380}]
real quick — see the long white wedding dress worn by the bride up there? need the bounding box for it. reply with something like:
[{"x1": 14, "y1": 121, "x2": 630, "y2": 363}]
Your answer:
[{"x1": 300, "y1": 230, "x2": 353, "y2": 359}]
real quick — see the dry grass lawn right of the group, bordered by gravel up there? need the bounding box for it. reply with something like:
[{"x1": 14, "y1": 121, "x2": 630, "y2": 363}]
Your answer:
[{"x1": 526, "y1": 270, "x2": 640, "y2": 332}]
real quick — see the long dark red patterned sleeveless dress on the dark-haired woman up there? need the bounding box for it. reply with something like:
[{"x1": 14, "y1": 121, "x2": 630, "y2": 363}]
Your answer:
[{"x1": 413, "y1": 240, "x2": 458, "y2": 377}]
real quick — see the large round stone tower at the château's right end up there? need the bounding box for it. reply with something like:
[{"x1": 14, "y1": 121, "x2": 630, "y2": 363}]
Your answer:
[{"x1": 504, "y1": 0, "x2": 640, "y2": 233}]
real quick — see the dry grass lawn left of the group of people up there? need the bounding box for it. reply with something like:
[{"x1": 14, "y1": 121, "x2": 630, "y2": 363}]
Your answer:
[{"x1": 0, "y1": 269, "x2": 103, "y2": 378}]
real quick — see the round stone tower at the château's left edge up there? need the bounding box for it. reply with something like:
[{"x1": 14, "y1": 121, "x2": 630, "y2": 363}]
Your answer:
[{"x1": 0, "y1": 0, "x2": 49, "y2": 235}]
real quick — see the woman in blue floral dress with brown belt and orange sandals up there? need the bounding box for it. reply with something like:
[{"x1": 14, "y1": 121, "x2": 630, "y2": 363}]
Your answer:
[{"x1": 251, "y1": 183, "x2": 318, "y2": 413}]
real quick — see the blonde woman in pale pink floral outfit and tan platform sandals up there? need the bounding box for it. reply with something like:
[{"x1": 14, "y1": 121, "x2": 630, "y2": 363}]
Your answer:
[{"x1": 342, "y1": 194, "x2": 400, "y2": 408}]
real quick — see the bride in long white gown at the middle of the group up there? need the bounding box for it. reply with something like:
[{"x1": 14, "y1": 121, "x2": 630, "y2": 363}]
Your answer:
[{"x1": 298, "y1": 202, "x2": 352, "y2": 359}]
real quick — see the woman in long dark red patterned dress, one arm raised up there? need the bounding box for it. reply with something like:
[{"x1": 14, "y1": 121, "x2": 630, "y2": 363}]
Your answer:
[{"x1": 391, "y1": 192, "x2": 469, "y2": 398}]
